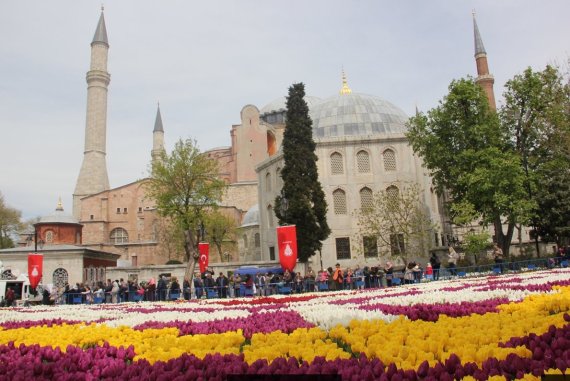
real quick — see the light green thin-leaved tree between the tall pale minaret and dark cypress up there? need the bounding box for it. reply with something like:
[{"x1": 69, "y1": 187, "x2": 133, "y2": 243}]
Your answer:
[{"x1": 146, "y1": 140, "x2": 226, "y2": 280}]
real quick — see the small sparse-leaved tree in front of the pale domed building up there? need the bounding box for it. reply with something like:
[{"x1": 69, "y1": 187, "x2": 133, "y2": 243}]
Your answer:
[{"x1": 354, "y1": 184, "x2": 436, "y2": 260}]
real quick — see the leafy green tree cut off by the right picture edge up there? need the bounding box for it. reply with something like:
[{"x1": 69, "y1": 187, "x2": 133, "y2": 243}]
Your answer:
[{"x1": 499, "y1": 66, "x2": 570, "y2": 243}]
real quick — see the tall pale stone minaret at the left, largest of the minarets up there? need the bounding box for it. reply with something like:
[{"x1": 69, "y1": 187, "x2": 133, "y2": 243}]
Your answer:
[{"x1": 73, "y1": 9, "x2": 111, "y2": 219}]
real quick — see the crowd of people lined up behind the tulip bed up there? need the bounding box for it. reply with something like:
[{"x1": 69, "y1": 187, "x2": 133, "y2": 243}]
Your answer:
[{"x1": 15, "y1": 244, "x2": 570, "y2": 304}]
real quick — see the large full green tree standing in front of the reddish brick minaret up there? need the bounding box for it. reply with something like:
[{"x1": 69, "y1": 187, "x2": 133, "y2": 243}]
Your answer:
[{"x1": 407, "y1": 78, "x2": 536, "y2": 255}]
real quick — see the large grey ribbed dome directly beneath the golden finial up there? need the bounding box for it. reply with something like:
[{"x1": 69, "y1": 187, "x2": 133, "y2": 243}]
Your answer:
[{"x1": 309, "y1": 93, "x2": 408, "y2": 138}]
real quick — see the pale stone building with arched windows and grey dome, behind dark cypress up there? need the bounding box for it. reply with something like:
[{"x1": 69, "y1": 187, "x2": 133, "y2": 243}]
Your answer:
[{"x1": 256, "y1": 78, "x2": 440, "y2": 268}]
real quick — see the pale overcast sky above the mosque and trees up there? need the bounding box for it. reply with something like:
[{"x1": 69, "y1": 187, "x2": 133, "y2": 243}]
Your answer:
[{"x1": 0, "y1": 0, "x2": 570, "y2": 220}]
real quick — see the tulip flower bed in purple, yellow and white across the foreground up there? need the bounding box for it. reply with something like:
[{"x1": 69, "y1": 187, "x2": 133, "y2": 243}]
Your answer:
[{"x1": 0, "y1": 269, "x2": 570, "y2": 380}]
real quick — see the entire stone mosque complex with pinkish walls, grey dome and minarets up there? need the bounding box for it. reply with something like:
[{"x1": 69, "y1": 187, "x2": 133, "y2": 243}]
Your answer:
[{"x1": 64, "y1": 13, "x2": 494, "y2": 267}]
